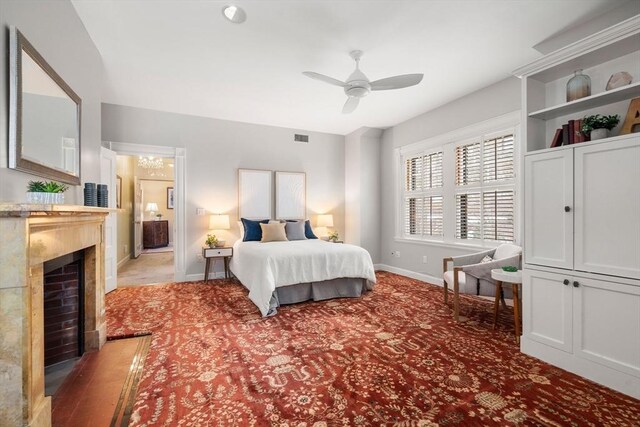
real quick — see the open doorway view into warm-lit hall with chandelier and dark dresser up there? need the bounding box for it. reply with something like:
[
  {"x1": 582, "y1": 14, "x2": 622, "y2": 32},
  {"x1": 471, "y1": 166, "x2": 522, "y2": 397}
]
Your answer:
[{"x1": 116, "y1": 155, "x2": 175, "y2": 287}]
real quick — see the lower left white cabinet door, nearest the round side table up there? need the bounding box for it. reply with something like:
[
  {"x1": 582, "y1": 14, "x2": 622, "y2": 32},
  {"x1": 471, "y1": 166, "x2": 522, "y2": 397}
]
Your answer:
[{"x1": 522, "y1": 269, "x2": 572, "y2": 353}]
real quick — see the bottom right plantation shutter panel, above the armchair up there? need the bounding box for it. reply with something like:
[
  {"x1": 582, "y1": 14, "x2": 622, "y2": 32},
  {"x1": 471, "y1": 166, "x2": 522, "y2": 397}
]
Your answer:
[{"x1": 482, "y1": 190, "x2": 515, "y2": 242}]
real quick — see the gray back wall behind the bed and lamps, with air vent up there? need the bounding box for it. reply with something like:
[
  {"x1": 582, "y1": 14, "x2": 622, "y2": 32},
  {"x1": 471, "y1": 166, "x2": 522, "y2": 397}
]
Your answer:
[{"x1": 102, "y1": 104, "x2": 345, "y2": 275}]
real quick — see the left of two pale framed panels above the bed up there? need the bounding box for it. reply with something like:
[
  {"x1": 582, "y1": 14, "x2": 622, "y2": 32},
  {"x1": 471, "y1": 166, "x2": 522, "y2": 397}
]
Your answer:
[{"x1": 238, "y1": 169, "x2": 273, "y2": 219}]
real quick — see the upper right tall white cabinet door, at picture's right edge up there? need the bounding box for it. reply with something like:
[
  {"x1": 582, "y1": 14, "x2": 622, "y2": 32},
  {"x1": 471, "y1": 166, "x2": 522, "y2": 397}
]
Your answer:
[{"x1": 574, "y1": 140, "x2": 640, "y2": 279}]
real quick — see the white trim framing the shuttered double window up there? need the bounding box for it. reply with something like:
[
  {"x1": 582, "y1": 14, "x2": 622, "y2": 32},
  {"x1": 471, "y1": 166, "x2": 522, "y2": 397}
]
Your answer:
[{"x1": 394, "y1": 110, "x2": 522, "y2": 248}]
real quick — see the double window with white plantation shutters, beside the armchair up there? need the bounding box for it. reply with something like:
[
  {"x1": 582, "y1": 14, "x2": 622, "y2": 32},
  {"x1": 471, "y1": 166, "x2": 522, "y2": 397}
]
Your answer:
[{"x1": 398, "y1": 120, "x2": 516, "y2": 245}]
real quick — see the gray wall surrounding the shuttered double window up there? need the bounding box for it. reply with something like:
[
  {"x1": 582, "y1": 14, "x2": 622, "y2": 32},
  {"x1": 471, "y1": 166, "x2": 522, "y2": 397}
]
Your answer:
[{"x1": 380, "y1": 77, "x2": 520, "y2": 277}]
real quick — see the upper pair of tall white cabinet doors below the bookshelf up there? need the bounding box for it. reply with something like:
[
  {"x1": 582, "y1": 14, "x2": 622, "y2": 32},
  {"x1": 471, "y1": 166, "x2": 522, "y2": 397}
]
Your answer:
[{"x1": 524, "y1": 135, "x2": 640, "y2": 279}]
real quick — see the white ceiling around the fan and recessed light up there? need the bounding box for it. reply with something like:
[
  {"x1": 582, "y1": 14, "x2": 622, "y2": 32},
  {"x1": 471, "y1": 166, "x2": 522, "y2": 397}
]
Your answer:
[{"x1": 72, "y1": 0, "x2": 624, "y2": 135}]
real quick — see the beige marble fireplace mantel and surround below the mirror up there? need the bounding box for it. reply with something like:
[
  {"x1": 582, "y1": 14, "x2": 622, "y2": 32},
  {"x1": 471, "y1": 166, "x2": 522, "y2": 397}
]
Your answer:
[{"x1": 0, "y1": 203, "x2": 111, "y2": 426}]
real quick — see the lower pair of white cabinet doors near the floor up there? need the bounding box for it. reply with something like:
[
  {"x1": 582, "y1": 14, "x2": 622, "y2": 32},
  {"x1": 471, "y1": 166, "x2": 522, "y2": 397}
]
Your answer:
[{"x1": 523, "y1": 269, "x2": 640, "y2": 382}]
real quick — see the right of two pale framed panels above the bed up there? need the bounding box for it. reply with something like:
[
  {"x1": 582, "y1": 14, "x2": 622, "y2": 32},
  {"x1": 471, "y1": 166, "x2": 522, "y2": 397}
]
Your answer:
[{"x1": 276, "y1": 172, "x2": 307, "y2": 219}]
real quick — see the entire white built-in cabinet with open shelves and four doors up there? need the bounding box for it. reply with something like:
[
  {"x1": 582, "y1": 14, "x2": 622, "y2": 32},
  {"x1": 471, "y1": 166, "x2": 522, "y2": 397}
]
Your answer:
[{"x1": 514, "y1": 15, "x2": 640, "y2": 398}]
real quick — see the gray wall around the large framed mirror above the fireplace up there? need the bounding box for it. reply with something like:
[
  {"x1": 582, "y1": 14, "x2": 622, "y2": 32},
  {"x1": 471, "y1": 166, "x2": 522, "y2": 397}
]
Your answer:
[{"x1": 0, "y1": 0, "x2": 102, "y2": 204}]
